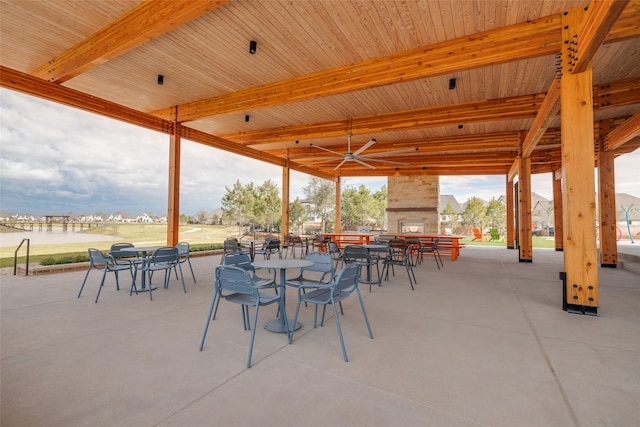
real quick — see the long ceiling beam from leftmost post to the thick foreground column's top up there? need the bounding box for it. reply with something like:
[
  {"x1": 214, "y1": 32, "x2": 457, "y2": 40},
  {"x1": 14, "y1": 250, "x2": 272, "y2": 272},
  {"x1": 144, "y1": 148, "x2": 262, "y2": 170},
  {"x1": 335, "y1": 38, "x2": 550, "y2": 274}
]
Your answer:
[{"x1": 152, "y1": 0, "x2": 640, "y2": 122}]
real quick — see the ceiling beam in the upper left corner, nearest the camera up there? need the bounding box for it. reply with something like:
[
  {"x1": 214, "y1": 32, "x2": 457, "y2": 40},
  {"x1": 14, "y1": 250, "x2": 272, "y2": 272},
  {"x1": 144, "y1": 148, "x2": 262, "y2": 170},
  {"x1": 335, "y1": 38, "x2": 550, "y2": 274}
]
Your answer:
[{"x1": 31, "y1": 0, "x2": 229, "y2": 83}]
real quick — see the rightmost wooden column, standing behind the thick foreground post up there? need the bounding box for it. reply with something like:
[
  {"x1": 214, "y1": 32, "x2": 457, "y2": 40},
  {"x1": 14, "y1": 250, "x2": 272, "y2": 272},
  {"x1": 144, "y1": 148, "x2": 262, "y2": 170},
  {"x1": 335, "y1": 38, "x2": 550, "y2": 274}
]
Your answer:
[{"x1": 598, "y1": 147, "x2": 618, "y2": 268}]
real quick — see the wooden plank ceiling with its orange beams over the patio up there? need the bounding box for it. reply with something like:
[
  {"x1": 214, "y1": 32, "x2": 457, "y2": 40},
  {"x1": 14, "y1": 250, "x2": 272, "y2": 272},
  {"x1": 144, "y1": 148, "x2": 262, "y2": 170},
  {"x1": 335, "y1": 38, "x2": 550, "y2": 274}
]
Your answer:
[{"x1": 0, "y1": 0, "x2": 640, "y2": 178}]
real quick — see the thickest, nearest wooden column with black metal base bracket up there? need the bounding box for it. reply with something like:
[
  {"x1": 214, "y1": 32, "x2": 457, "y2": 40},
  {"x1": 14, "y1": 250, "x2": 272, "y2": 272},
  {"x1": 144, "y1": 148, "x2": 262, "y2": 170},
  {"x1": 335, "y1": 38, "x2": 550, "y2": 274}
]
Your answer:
[{"x1": 560, "y1": 8, "x2": 598, "y2": 314}]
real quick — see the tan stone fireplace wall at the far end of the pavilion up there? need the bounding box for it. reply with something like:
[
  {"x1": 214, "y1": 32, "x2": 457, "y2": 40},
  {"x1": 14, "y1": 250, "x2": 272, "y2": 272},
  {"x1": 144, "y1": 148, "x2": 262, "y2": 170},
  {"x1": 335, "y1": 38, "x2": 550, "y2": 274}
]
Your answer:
[{"x1": 387, "y1": 176, "x2": 440, "y2": 234}]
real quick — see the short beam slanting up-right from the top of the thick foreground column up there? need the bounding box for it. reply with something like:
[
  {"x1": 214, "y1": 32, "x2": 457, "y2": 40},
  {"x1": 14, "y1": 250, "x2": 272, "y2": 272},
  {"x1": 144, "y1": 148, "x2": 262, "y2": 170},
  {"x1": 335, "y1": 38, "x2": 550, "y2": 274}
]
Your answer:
[{"x1": 569, "y1": 0, "x2": 629, "y2": 74}]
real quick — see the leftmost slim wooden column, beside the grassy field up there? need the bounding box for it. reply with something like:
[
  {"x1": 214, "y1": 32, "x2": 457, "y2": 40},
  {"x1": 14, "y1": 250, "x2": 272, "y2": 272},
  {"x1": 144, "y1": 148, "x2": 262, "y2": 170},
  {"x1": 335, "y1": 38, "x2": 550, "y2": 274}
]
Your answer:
[{"x1": 167, "y1": 122, "x2": 181, "y2": 246}]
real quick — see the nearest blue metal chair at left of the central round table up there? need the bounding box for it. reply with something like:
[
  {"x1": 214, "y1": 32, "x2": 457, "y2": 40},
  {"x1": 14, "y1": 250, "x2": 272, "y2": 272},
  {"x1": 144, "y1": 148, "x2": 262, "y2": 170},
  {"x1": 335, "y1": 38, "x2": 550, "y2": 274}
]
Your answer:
[{"x1": 200, "y1": 265, "x2": 290, "y2": 368}]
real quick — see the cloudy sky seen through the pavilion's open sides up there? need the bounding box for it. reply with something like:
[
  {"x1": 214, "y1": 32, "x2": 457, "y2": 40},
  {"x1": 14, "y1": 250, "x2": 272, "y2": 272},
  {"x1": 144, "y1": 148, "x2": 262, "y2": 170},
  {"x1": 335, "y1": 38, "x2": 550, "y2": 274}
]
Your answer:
[{"x1": 0, "y1": 89, "x2": 640, "y2": 215}]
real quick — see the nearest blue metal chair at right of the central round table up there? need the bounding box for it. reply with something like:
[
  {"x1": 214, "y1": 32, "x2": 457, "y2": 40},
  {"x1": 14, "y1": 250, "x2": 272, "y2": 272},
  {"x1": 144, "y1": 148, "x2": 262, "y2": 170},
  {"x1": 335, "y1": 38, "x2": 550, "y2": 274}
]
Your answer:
[{"x1": 289, "y1": 262, "x2": 373, "y2": 362}]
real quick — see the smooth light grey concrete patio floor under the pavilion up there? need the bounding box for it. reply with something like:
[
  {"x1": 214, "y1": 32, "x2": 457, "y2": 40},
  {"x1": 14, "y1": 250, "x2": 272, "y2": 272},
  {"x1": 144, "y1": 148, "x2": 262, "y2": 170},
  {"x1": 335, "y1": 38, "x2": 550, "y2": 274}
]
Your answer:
[{"x1": 0, "y1": 247, "x2": 640, "y2": 427}]
